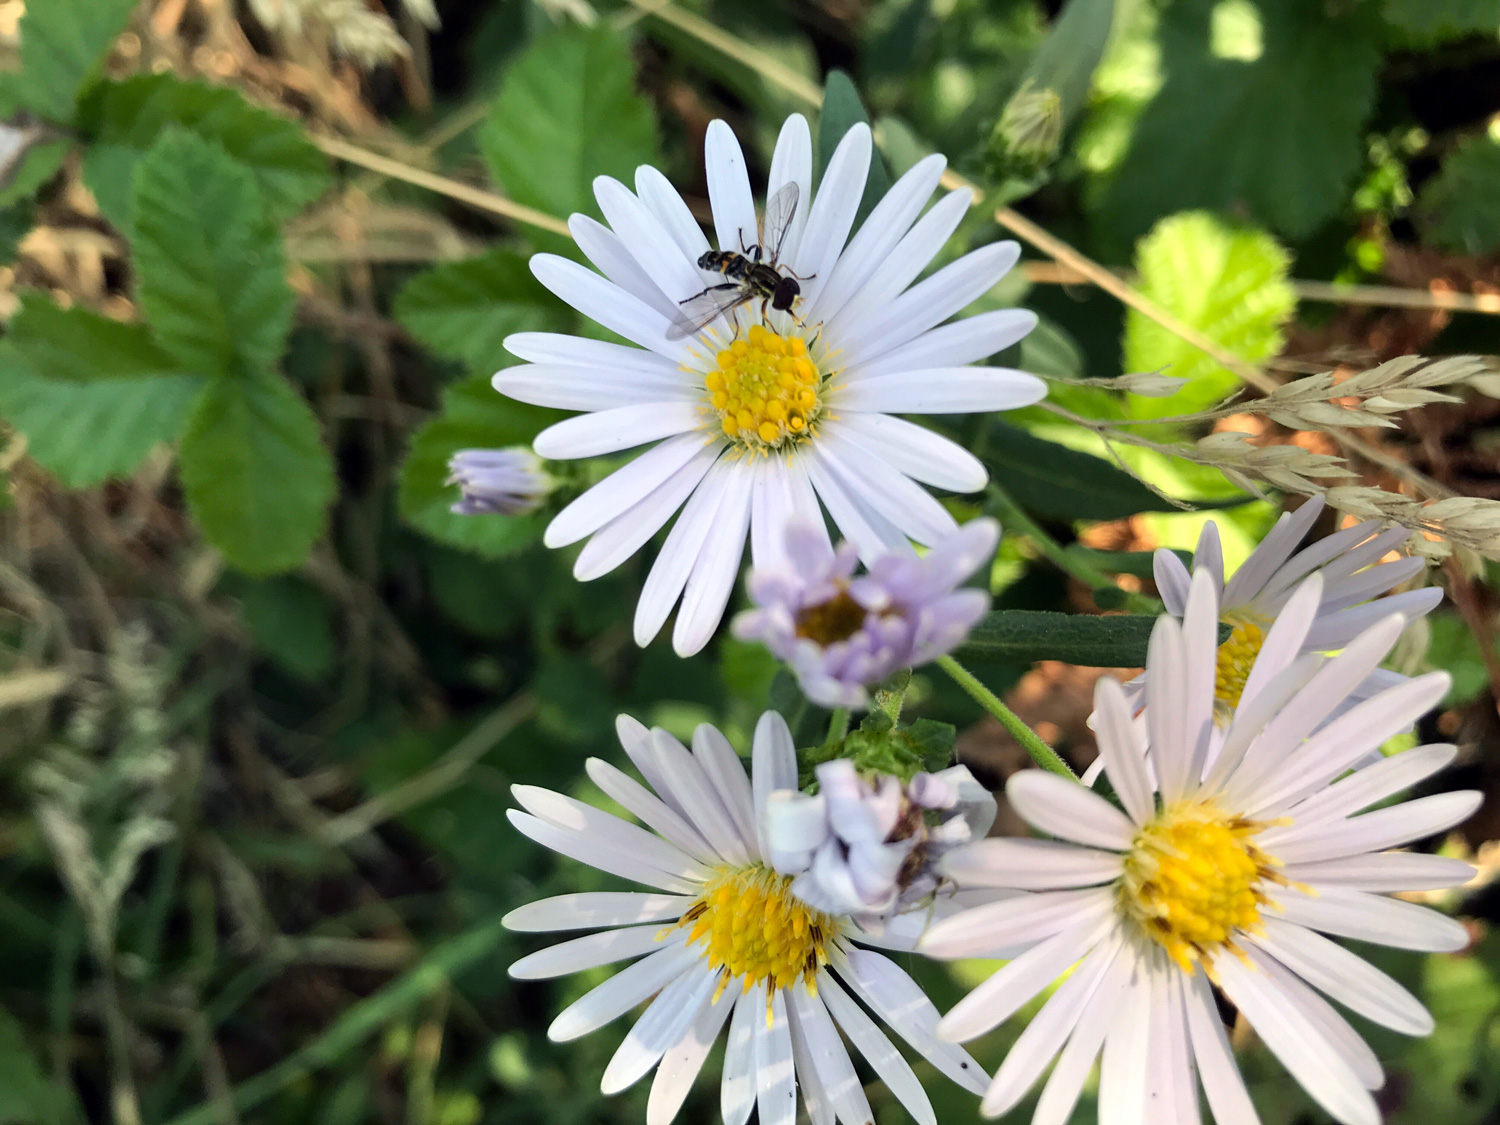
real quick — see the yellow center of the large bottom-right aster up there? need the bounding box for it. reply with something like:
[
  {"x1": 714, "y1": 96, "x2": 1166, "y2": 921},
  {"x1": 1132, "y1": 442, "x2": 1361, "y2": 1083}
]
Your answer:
[{"x1": 1119, "y1": 801, "x2": 1286, "y2": 972}]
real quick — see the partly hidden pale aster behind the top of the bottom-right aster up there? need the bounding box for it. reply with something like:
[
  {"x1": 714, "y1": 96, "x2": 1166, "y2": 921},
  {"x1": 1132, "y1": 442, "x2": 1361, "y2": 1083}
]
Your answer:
[{"x1": 1133, "y1": 497, "x2": 1443, "y2": 723}]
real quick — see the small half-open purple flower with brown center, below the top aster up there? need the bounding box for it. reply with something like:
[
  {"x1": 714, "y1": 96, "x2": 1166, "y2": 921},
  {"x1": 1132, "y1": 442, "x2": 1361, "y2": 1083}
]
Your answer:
[{"x1": 734, "y1": 519, "x2": 1001, "y2": 707}]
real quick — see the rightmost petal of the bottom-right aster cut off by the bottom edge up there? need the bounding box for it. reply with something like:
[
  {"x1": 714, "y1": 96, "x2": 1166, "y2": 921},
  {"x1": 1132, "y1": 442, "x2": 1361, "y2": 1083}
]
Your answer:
[{"x1": 1217, "y1": 957, "x2": 1380, "y2": 1125}]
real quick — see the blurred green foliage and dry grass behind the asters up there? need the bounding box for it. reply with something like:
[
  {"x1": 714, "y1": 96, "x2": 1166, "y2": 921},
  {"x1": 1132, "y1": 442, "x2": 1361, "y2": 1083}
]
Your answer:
[{"x1": 0, "y1": 0, "x2": 1500, "y2": 1125}]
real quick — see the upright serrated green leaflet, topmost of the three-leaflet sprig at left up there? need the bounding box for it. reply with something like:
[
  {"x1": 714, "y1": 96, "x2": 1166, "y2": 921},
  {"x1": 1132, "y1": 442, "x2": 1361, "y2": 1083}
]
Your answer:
[{"x1": 132, "y1": 126, "x2": 296, "y2": 375}]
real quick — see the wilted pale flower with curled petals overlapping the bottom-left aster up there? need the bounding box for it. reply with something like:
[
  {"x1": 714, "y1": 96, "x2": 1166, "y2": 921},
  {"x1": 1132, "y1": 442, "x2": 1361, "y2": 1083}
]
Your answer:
[{"x1": 764, "y1": 758, "x2": 995, "y2": 935}]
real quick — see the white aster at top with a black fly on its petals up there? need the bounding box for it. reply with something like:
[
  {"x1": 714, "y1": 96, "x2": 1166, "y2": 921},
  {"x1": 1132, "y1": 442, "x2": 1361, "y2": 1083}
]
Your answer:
[{"x1": 495, "y1": 116, "x2": 1046, "y2": 656}]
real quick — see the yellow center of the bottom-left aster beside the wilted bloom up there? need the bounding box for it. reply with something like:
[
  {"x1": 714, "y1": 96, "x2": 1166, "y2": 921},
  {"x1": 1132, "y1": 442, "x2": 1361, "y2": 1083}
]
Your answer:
[{"x1": 665, "y1": 864, "x2": 839, "y2": 1020}]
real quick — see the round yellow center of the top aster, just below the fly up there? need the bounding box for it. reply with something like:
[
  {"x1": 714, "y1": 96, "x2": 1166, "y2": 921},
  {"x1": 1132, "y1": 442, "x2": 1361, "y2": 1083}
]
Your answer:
[{"x1": 704, "y1": 324, "x2": 824, "y2": 450}]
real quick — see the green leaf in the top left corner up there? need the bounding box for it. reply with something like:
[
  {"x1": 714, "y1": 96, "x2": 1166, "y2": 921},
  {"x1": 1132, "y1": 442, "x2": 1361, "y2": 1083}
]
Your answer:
[{"x1": 11, "y1": 0, "x2": 140, "y2": 123}]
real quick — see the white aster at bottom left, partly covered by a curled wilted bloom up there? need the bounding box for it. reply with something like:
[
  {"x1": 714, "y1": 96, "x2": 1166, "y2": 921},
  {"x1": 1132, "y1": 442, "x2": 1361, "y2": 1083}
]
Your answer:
[{"x1": 506, "y1": 711, "x2": 986, "y2": 1125}]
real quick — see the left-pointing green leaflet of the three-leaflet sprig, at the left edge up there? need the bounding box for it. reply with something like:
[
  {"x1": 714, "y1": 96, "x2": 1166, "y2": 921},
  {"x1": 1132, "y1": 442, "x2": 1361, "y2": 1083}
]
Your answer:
[{"x1": 0, "y1": 294, "x2": 203, "y2": 488}]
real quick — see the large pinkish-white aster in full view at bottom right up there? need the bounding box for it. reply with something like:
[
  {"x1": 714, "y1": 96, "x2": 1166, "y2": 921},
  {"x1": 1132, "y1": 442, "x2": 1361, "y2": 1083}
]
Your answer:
[{"x1": 920, "y1": 570, "x2": 1481, "y2": 1125}]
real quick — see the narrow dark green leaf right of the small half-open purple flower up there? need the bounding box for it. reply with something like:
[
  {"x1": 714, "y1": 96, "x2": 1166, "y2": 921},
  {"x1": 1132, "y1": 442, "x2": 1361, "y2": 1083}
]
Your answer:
[{"x1": 954, "y1": 609, "x2": 1230, "y2": 668}]
